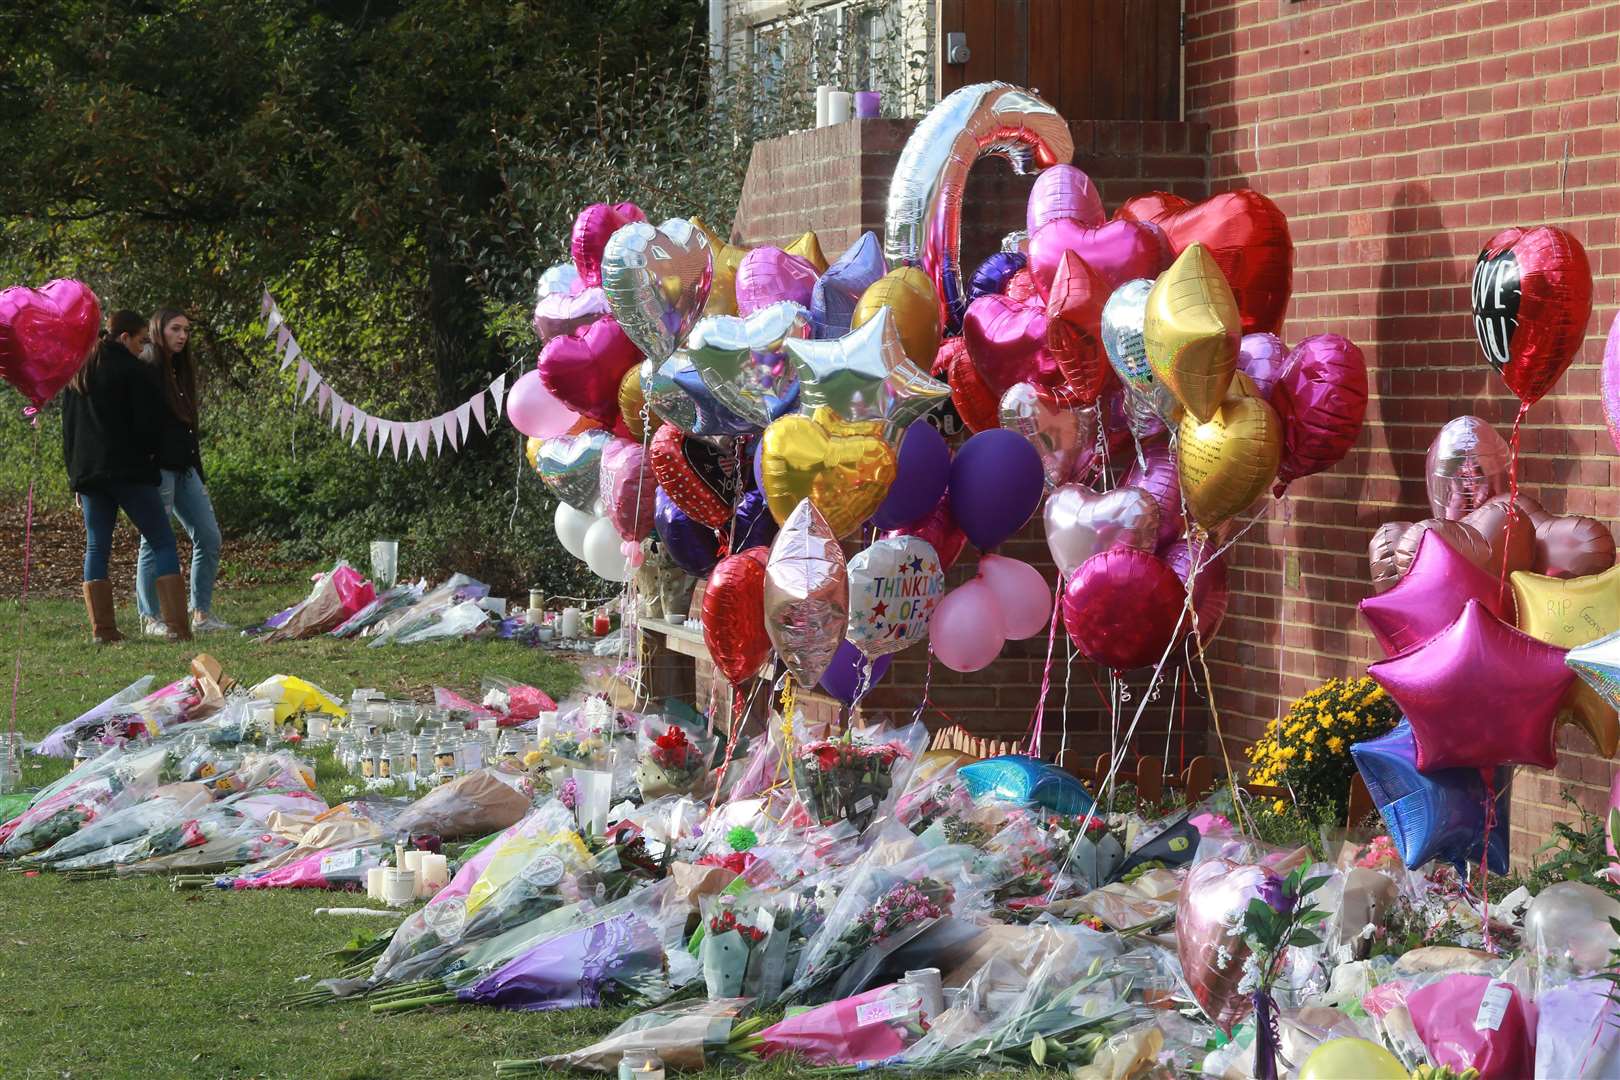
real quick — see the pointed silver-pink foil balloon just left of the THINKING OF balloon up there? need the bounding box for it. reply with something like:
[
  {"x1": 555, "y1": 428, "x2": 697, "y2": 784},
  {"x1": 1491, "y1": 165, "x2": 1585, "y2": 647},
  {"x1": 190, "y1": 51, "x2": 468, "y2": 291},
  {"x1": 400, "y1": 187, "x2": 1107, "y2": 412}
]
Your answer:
[{"x1": 765, "y1": 499, "x2": 849, "y2": 687}]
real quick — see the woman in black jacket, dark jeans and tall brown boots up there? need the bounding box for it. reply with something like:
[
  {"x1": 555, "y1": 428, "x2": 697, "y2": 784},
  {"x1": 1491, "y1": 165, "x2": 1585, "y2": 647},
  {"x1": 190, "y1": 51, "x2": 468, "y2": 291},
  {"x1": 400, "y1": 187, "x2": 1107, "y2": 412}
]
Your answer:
[{"x1": 62, "y1": 311, "x2": 191, "y2": 644}]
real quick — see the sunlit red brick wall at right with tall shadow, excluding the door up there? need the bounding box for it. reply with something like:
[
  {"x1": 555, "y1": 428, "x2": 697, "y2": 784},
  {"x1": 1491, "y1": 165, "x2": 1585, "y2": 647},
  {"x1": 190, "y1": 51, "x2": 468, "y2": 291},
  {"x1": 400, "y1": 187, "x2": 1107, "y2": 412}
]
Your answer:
[{"x1": 1186, "y1": 0, "x2": 1620, "y2": 857}]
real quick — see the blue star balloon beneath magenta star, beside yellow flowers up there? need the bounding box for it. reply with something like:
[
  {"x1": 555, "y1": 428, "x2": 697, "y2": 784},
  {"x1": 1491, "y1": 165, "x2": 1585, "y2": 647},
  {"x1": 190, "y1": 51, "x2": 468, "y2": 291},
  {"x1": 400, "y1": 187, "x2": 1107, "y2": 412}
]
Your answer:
[{"x1": 1349, "y1": 719, "x2": 1513, "y2": 874}]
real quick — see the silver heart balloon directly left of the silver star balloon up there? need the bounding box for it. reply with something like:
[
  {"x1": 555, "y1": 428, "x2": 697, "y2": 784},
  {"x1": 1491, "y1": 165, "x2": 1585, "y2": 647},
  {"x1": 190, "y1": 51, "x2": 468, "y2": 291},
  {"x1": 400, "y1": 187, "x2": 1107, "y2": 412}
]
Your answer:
[{"x1": 682, "y1": 300, "x2": 810, "y2": 427}]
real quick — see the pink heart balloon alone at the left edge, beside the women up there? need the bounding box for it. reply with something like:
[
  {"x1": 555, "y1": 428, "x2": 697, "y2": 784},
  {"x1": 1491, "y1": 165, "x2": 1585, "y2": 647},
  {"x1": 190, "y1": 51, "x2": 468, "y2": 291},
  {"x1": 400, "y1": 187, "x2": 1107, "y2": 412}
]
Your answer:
[{"x1": 0, "y1": 277, "x2": 100, "y2": 408}]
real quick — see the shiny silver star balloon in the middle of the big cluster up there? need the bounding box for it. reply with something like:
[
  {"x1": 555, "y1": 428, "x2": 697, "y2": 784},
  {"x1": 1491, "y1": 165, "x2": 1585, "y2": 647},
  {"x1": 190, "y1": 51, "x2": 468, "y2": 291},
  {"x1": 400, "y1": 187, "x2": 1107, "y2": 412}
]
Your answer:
[{"x1": 782, "y1": 308, "x2": 951, "y2": 444}]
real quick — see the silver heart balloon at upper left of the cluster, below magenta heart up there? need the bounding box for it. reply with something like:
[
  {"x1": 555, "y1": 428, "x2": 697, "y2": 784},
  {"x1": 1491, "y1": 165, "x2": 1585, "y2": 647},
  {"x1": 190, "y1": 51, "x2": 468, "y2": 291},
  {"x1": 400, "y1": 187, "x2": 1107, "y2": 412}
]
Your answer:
[{"x1": 603, "y1": 217, "x2": 714, "y2": 363}]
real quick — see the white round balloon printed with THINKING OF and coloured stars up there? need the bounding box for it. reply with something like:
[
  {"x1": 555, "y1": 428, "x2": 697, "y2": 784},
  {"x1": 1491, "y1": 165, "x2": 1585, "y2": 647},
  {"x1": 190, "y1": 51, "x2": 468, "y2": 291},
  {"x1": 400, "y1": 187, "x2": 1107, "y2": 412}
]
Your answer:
[{"x1": 847, "y1": 536, "x2": 944, "y2": 659}]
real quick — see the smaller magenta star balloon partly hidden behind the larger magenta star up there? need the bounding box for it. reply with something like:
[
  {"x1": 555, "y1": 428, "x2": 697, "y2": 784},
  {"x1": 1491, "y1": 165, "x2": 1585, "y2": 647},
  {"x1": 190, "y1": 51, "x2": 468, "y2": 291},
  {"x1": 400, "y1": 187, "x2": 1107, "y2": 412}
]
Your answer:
[{"x1": 1359, "y1": 529, "x2": 1508, "y2": 656}]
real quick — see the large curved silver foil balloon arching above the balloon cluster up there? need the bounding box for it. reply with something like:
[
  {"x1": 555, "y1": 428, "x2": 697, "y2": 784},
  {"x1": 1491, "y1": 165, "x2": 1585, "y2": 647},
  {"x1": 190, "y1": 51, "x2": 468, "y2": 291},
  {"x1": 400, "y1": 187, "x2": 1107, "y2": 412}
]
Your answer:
[{"x1": 883, "y1": 83, "x2": 1074, "y2": 330}]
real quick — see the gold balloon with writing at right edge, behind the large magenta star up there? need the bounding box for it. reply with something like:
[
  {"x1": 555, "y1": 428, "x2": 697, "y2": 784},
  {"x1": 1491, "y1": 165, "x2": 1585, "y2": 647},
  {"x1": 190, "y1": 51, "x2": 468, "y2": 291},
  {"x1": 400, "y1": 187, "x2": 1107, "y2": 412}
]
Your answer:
[{"x1": 1510, "y1": 567, "x2": 1620, "y2": 758}]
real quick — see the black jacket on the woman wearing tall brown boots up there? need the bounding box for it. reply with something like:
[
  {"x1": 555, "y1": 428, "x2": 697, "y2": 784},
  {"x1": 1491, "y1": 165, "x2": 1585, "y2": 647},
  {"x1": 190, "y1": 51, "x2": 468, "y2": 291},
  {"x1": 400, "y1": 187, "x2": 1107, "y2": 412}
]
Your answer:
[{"x1": 62, "y1": 342, "x2": 170, "y2": 492}]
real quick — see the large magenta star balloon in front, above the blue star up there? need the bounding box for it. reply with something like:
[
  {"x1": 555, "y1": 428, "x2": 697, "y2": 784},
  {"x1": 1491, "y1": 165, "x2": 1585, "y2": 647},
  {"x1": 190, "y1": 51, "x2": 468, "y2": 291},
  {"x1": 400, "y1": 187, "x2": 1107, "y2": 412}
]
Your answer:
[{"x1": 1367, "y1": 599, "x2": 1575, "y2": 772}]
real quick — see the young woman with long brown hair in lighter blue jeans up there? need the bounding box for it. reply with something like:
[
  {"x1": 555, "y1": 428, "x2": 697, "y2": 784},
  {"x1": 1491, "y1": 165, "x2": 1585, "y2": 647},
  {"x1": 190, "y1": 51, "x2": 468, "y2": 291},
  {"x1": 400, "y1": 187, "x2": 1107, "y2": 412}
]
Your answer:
[{"x1": 134, "y1": 308, "x2": 230, "y2": 635}]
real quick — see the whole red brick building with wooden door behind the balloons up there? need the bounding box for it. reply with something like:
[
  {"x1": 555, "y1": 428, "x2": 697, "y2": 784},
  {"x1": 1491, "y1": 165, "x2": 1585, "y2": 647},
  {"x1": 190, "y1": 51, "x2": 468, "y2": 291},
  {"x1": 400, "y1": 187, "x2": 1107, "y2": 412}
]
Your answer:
[{"x1": 664, "y1": 0, "x2": 1620, "y2": 857}]
